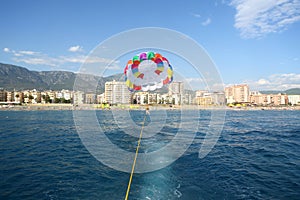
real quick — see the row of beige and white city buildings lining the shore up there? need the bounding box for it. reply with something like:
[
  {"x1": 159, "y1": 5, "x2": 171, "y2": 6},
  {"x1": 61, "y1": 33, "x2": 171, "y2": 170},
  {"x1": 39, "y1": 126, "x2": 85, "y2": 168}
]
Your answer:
[{"x1": 0, "y1": 80, "x2": 300, "y2": 108}]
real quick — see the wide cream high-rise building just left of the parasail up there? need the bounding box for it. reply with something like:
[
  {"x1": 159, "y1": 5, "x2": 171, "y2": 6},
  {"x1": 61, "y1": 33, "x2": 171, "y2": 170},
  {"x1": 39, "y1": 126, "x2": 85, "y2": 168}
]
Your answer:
[{"x1": 105, "y1": 80, "x2": 131, "y2": 104}]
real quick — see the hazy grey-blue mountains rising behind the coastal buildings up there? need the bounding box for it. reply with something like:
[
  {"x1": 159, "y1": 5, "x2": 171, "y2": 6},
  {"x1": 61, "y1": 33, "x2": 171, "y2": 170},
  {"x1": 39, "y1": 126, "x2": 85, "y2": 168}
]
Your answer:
[{"x1": 0, "y1": 63, "x2": 300, "y2": 95}]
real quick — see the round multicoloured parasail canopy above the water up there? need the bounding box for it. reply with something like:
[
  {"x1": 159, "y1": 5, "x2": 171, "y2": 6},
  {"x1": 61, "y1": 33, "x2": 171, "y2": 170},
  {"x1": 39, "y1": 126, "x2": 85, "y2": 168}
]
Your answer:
[{"x1": 124, "y1": 52, "x2": 173, "y2": 92}]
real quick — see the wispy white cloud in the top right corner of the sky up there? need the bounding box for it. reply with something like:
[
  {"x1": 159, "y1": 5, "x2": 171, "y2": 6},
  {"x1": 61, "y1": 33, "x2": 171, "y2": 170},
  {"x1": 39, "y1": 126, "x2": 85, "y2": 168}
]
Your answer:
[{"x1": 230, "y1": 0, "x2": 300, "y2": 38}]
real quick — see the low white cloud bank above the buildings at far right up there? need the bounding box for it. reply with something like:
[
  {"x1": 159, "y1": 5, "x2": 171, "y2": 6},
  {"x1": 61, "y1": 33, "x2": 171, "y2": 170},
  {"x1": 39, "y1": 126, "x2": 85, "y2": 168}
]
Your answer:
[{"x1": 245, "y1": 73, "x2": 300, "y2": 90}]
